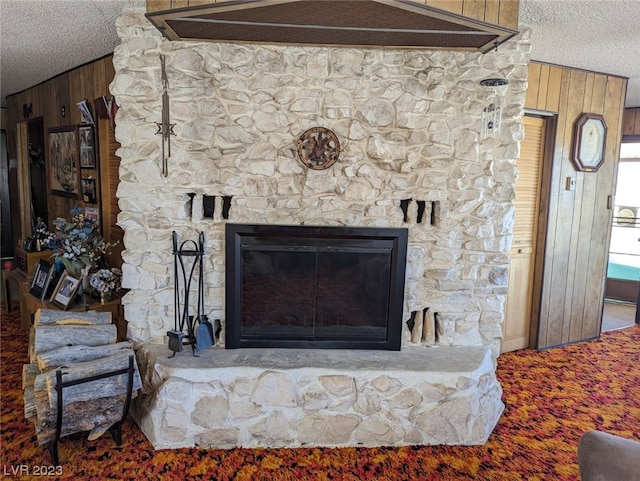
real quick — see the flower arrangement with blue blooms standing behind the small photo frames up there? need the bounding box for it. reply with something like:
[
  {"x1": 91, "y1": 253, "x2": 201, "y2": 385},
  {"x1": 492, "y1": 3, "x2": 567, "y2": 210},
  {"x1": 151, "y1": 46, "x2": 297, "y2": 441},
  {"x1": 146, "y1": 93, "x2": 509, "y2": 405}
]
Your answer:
[{"x1": 36, "y1": 207, "x2": 117, "y2": 276}]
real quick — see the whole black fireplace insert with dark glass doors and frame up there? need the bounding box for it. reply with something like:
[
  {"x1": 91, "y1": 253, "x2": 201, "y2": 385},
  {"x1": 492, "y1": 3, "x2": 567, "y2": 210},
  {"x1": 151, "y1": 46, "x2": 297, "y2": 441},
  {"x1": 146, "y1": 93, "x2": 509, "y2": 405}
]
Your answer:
[{"x1": 225, "y1": 224, "x2": 407, "y2": 351}]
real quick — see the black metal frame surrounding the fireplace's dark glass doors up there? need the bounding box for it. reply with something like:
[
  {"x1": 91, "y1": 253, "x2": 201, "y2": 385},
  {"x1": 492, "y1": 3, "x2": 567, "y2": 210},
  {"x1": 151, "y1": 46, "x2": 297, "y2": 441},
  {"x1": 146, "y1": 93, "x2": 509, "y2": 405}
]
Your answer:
[{"x1": 225, "y1": 224, "x2": 408, "y2": 351}]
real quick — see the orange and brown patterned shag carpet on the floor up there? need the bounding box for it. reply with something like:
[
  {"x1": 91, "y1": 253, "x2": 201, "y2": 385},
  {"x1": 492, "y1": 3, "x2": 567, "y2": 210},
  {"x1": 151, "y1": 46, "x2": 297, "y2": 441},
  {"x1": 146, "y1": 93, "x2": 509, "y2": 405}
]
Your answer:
[{"x1": 0, "y1": 308, "x2": 640, "y2": 481}]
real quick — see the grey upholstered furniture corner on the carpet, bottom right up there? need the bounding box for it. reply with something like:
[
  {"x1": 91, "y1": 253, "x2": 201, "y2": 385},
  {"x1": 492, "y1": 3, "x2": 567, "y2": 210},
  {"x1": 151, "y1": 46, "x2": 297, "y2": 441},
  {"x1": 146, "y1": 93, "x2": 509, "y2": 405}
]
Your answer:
[{"x1": 578, "y1": 431, "x2": 640, "y2": 481}]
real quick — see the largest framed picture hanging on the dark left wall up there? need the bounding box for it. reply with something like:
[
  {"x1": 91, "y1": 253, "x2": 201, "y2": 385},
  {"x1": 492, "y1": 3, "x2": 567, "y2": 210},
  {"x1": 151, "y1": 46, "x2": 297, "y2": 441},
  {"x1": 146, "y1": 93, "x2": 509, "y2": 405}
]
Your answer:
[{"x1": 49, "y1": 125, "x2": 80, "y2": 199}]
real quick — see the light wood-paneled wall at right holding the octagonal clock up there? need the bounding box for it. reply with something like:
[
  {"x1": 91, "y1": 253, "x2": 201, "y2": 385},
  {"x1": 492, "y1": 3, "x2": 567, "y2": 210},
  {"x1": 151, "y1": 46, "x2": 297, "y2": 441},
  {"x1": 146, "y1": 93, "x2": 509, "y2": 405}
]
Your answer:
[{"x1": 525, "y1": 63, "x2": 627, "y2": 348}]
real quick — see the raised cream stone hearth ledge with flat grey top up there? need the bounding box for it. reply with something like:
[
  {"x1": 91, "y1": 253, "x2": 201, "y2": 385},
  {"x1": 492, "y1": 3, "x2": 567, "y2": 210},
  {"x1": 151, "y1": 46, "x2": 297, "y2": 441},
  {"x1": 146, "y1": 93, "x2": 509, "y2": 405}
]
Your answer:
[{"x1": 133, "y1": 344, "x2": 504, "y2": 449}]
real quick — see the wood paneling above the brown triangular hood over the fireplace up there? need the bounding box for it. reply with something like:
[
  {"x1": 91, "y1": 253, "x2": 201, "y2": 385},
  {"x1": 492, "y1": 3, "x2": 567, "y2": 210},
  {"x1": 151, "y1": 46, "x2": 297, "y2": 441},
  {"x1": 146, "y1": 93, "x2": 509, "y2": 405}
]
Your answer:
[{"x1": 147, "y1": 0, "x2": 520, "y2": 30}]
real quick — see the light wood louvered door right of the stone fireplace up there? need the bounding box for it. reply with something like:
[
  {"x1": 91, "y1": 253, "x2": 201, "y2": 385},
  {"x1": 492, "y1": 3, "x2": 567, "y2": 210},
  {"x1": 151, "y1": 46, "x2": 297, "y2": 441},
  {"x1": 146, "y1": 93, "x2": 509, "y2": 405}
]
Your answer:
[{"x1": 501, "y1": 116, "x2": 545, "y2": 352}]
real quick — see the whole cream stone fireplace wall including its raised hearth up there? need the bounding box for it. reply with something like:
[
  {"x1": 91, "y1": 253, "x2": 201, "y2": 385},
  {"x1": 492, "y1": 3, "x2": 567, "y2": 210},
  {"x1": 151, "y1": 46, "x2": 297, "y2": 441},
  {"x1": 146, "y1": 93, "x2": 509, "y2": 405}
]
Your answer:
[{"x1": 111, "y1": 11, "x2": 530, "y2": 448}]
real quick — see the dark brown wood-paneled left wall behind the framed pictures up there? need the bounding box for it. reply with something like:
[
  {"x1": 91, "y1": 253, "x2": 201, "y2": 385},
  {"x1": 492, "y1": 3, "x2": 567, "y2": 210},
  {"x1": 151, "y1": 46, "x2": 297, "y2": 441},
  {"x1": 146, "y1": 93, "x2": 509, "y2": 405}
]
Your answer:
[{"x1": 7, "y1": 55, "x2": 121, "y2": 264}]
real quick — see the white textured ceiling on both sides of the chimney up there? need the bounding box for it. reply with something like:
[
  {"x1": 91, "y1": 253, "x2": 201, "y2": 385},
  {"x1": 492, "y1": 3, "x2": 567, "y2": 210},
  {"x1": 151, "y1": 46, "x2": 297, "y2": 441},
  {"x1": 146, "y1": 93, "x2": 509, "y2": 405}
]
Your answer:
[{"x1": 0, "y1": 0, "x2": 640, "y2": 107}]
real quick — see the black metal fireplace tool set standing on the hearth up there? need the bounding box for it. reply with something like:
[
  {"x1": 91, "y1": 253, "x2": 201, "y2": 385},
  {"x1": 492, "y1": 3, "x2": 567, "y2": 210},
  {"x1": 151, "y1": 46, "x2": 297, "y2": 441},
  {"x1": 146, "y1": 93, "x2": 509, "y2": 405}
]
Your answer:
[{"x1": 167, "y1": 231, "x2": 215, "y2": 357}]
